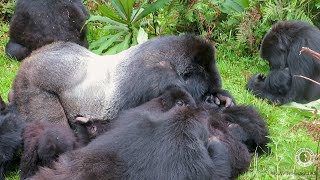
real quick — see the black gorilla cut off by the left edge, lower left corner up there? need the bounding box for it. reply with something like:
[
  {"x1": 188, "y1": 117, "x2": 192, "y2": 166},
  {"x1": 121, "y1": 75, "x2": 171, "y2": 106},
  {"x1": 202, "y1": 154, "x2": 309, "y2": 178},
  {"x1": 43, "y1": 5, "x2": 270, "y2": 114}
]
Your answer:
[{"x1": 0, "y1": 97, "x2": 24, "y2": 179}]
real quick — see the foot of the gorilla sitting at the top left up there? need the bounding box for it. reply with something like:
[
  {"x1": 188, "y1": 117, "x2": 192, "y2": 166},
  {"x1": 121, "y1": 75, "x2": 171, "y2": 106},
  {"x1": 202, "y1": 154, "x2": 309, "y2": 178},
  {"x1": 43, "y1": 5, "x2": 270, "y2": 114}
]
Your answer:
[{"x1": 5, "y1": 39, "x2": 30, "y2": 60}]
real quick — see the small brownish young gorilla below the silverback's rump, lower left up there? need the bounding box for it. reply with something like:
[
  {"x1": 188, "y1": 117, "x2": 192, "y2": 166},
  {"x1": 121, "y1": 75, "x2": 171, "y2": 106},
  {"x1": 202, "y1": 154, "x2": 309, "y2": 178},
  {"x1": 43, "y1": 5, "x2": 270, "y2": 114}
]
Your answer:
[{"x1": 20, "y1": 122, "x2": 86, "y2": 179}]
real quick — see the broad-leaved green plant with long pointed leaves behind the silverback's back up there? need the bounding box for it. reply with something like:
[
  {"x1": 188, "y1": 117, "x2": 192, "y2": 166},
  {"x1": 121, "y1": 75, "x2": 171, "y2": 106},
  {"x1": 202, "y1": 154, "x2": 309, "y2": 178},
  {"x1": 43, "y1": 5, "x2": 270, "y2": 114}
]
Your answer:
[{"x1": 87, "y1": 0, "x2": 171, "y2": 54}]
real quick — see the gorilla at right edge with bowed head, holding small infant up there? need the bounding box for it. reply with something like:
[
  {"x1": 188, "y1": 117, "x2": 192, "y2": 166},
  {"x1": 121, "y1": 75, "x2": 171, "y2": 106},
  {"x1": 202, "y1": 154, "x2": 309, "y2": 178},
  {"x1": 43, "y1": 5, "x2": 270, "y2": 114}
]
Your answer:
[{"x1": 247, "y1": 21, "x2": 320, "y2": 104}]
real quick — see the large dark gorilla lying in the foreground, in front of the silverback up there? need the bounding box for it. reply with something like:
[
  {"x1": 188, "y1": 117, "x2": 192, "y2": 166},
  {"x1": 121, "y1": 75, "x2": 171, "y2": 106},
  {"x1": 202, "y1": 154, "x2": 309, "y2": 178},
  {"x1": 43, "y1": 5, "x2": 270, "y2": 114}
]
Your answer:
[{"x1": 30, "y1": 88, "x2": 266, "y2": 180}]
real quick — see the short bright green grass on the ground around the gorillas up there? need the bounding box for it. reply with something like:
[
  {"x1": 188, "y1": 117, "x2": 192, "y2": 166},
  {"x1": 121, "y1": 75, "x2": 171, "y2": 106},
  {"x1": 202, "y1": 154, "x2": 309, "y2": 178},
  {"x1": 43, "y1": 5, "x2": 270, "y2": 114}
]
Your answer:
[{"x1": 0, "y1": 22, "x2": 317, "y2": 180}]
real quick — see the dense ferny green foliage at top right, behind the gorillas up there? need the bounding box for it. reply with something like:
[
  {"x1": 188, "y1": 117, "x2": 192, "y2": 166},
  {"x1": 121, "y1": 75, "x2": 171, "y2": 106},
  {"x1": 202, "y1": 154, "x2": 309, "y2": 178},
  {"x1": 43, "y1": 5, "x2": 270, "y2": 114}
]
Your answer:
[{"x1": 164, "y1": 0, "x2": 320, "y2": 56}]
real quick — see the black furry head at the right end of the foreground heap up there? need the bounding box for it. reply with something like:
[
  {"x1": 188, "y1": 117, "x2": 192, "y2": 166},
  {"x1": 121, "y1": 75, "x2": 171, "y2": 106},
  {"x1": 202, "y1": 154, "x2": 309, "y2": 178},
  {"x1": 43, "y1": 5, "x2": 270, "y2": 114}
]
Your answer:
[{"x1": 199, "y1": 95, "x2": 271, "y2": 154}]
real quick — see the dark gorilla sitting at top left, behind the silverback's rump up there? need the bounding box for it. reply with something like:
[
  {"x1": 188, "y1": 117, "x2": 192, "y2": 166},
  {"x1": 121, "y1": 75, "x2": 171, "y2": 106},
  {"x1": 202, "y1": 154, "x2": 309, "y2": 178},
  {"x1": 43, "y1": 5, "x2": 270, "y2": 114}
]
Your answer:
[{"x1": 6, "y1": 0, "x2": 88, "y2": 60}]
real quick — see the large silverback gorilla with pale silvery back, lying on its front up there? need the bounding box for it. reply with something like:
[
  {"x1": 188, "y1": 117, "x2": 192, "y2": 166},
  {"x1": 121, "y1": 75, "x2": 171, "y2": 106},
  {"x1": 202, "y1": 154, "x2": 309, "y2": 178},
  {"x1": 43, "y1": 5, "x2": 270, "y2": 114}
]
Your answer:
[{"x1": 13, "y1": 35, "x2": 232, "y2": 126}]
